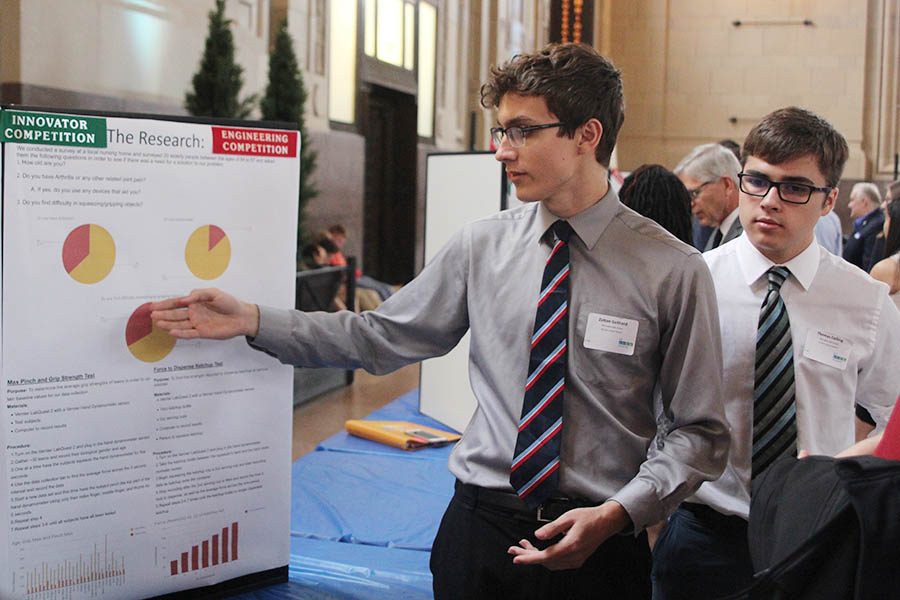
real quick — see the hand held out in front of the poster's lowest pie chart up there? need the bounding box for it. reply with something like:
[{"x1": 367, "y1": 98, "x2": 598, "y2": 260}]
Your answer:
[{"x1": 150, "y1": 288, "x2": 259, "y2": 340}]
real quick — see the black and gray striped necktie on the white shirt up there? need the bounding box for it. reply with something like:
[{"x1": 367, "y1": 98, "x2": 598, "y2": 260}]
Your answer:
[{"x1": 753, "y1": 267, "x2": 797, "y2": 477}]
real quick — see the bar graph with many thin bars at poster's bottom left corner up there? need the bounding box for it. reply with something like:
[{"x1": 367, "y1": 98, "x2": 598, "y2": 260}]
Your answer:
[{"x1": 21, "y1": 536, "x2": 126, "y2": 600}]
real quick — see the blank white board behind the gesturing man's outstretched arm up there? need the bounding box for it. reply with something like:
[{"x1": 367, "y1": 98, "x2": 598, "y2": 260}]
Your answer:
[{"x1": 419, "y1": 152, "x2": 506, "y2": 431}]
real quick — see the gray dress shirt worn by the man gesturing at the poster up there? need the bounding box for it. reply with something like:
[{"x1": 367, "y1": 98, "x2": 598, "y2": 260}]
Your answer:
[{"x1": 252, "y1": 191, "x2": 729, "y2": 531}]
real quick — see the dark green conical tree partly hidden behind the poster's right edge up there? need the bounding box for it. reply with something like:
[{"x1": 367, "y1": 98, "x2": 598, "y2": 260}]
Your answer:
[{"x1": 260, "y1": 19, "x2": 319, "y2": 248}]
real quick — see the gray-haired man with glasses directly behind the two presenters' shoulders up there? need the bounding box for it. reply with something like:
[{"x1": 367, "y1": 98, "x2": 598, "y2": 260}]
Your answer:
[{"x1": 675, "y1": 144, "x2": 742, "y2": 252}]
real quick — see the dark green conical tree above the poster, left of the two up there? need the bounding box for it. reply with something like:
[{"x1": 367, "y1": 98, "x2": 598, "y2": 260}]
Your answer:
[{"x1": 184, "y1": 0, "x2": 257, "y2": 119}]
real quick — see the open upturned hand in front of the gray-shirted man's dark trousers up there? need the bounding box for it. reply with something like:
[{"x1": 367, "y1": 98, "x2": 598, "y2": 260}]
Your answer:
[{"x1": 507, "y1": 501, "x2": 630, "y2": 571}]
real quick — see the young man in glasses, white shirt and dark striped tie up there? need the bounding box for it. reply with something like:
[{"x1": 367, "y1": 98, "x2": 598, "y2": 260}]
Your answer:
[{"x1": 653, "y1": 107, "x2": 900, "y2": 600}]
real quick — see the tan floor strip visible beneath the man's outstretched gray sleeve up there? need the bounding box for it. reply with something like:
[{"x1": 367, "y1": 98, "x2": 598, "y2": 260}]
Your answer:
[{"x1": 292, "y1": 364, "x2": 419, "y2": 460}]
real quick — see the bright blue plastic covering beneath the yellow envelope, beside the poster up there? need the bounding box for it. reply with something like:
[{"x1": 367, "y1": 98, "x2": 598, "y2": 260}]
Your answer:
[{"x1": 234, "y1": 390, "x2": 453, "y2": 600}]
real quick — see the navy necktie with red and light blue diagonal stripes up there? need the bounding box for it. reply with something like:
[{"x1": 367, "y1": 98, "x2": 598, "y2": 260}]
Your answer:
[{"x1": 509, "y1": 221, "x2": 572, "y2": 507}]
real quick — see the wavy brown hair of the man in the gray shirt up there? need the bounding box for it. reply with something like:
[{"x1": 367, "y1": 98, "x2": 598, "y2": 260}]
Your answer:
[{"x1": 481, "y1": 44, "x2": 625, "y2": 167}]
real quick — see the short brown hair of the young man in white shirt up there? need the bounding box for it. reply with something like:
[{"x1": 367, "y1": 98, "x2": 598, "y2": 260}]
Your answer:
[{"x1": 742, "y1": 106, "x2": 850, "y2": 187}]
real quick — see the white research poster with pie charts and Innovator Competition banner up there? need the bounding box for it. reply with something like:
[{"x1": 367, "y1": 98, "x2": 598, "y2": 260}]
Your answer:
[{"x1": 0, "y1": 110, "x2": 300, "y2": 600}]
